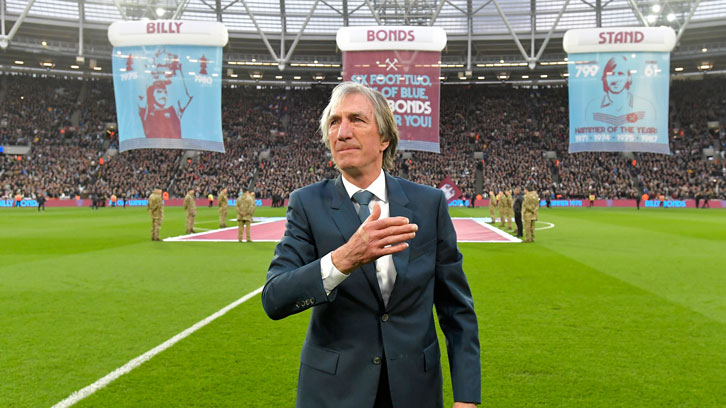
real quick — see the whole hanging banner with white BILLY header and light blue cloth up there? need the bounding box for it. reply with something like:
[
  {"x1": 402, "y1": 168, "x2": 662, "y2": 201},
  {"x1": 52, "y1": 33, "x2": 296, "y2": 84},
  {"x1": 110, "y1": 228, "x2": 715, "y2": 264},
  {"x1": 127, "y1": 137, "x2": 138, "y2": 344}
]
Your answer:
[{"x1": 108, "y1": 20, "x2": 228, "y2": 152}]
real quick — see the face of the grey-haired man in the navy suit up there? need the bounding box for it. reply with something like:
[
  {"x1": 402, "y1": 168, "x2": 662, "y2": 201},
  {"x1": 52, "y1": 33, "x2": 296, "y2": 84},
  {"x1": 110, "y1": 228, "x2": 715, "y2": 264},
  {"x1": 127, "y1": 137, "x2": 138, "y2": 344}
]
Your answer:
[{"x1": 328, "y1": 93, "x2": 388, "y2": 177}]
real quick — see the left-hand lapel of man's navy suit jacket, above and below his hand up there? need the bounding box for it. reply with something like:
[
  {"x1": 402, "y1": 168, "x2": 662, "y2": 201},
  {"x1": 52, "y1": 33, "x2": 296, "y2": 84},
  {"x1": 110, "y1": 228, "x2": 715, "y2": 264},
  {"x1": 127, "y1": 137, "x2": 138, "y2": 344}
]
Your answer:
[{"x1": 330, "y1": 175, "x2": 383, "y2": 304}]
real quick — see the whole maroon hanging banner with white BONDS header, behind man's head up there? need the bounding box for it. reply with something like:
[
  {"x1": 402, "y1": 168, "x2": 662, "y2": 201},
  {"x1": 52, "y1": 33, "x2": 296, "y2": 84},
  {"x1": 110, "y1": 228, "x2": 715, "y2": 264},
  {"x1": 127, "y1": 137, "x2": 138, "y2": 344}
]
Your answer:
[{"x1": 336, "y1": 26, "x2": 446, "y2": 153}]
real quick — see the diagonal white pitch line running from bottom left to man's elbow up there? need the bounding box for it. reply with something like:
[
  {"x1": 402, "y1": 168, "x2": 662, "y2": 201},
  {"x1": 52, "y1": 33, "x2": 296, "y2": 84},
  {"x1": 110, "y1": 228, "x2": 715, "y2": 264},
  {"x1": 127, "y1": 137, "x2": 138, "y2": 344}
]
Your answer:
[{"x1": 52, "y1": 286, "x2": 263, "y2": 408}]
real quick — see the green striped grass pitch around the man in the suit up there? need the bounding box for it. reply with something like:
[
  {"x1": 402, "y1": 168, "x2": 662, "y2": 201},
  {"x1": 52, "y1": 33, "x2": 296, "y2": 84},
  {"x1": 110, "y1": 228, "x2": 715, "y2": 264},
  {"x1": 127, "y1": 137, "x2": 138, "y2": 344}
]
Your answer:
[{"x1": 0, "y1": 207, "x2": 726, "y2": 408}]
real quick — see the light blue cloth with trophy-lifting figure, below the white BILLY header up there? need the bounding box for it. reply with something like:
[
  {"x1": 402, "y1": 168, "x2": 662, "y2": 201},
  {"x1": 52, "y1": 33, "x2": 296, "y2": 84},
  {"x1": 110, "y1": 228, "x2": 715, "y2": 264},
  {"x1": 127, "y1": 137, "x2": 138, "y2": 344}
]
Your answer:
[{"x1": 113, "y1": 45, "x2": 224, "y2": 152}]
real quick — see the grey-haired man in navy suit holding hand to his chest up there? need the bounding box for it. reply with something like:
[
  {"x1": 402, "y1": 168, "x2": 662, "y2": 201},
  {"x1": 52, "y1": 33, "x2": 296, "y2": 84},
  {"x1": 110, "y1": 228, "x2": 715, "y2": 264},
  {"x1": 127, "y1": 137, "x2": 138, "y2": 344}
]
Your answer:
[{"x1": 262, "y1": 83, "x2": 481, "y2": 408}]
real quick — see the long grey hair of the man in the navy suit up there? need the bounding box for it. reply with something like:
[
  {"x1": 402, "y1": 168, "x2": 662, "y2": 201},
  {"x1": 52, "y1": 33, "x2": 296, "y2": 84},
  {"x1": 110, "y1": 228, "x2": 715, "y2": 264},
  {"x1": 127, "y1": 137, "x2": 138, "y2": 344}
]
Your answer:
[{"x1": 320, "y1": 82, "x2": 398, "y2": 171}]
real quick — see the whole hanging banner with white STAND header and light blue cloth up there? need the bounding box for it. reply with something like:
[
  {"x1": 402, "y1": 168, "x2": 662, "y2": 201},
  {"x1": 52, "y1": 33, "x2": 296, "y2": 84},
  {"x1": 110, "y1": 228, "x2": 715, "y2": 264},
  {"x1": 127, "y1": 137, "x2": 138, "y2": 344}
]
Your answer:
[{"x1": 563, "y1": 27, "x2": 676, "y2": 154}]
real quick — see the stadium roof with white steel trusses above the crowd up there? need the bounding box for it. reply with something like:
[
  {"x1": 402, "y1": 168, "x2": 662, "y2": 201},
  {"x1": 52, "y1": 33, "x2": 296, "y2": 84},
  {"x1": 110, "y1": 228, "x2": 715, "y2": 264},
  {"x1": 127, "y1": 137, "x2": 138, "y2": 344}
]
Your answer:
[{"x1": 0, "y1": 0, "x2": 726, "y2": 80}]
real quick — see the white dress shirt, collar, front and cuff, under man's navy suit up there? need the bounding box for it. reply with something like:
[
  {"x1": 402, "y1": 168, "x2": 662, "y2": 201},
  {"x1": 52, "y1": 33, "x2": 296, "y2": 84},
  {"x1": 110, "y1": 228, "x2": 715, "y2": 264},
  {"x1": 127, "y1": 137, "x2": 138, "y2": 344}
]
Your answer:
[{"x1": 320, "y1": 170, "x2": 396, "y2": 305}]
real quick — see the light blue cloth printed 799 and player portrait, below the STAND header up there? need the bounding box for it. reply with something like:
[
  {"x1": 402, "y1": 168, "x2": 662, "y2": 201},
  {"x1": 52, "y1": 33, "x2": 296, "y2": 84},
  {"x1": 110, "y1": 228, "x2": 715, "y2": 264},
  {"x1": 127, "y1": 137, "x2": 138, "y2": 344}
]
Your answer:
[{"x1": 568, "y1": 52, "x2": 670, "y2": 154}]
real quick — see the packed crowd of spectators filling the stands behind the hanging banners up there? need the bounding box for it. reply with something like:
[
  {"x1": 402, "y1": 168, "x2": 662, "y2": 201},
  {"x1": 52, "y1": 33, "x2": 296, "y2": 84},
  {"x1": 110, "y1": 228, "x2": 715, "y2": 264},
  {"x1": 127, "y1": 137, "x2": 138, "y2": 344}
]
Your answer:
[{"x1": 0, "y1": 75, "x2": 726, "y2": 203}]
